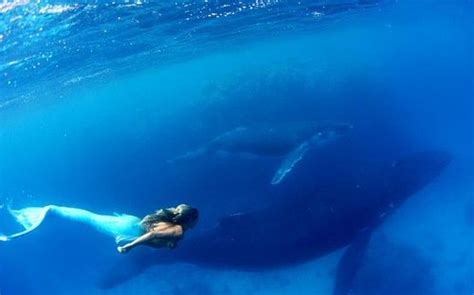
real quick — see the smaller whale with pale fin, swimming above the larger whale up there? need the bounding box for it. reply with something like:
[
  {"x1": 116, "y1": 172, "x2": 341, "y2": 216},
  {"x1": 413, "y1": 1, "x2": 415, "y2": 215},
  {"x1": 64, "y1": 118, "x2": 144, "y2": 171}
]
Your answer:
[{"x1": 169, "y1": 122, "x2": 352, "y2": 185}]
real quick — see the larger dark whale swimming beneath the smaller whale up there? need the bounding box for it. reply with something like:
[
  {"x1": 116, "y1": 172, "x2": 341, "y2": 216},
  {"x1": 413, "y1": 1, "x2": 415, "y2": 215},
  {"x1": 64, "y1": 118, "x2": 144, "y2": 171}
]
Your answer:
[{"x1": 101, "y1": 151, "x2": 450, "y2": 294}]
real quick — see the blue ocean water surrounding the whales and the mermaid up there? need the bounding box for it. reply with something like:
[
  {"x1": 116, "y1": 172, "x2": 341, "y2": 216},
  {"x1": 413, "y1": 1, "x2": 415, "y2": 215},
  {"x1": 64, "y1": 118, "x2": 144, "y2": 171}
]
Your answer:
[{"x1": 0, "y1": 0, "x2": 474, "y2": 295}]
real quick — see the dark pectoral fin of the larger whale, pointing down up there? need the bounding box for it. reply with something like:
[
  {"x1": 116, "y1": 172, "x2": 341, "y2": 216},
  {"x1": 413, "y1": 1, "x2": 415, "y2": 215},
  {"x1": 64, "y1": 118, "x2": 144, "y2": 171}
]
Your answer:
[{"x1": 332, "y1": 229, "x2": 372, "y2": 295}]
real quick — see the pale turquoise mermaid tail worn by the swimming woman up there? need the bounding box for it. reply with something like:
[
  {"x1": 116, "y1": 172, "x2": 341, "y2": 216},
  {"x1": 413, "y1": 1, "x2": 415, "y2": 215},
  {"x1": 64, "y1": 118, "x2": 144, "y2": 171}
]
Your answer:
[{"x1": 0, "y1": 205, "x2": 144, "y2": 244}]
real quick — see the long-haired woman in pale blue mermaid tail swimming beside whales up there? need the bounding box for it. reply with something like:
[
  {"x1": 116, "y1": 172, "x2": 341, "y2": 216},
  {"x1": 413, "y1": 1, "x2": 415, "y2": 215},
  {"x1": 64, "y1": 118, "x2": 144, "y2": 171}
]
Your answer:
[{"x1": 0, "y1": 204, "x2": 199, "y2": 253}]
